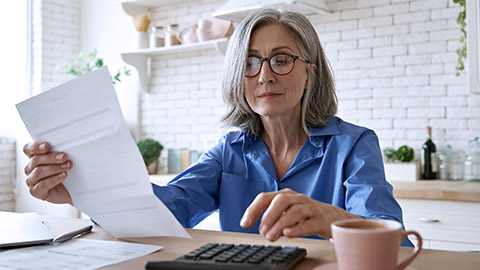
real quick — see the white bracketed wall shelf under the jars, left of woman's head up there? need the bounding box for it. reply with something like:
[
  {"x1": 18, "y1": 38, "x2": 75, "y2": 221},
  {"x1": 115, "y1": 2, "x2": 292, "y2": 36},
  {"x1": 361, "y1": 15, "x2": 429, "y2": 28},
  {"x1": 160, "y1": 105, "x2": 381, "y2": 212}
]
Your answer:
[{"x1": 122, "y1": 38, "x2": 228, "y2": 92}]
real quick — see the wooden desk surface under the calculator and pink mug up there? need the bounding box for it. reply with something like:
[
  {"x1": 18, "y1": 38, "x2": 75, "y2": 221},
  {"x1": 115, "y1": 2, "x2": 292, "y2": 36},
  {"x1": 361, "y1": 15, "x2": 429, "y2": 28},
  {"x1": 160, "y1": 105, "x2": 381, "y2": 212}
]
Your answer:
[{"x1": 36, "y1": 217, "x2": 480, "y2": 270}]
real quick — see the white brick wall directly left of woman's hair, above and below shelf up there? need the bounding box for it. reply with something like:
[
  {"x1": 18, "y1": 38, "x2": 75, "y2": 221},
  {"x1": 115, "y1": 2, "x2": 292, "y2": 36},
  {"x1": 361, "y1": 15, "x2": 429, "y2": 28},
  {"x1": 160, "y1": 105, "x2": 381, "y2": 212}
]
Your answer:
[{"x1": 141, "y1": 0, "x2": 225, "y2": 160}]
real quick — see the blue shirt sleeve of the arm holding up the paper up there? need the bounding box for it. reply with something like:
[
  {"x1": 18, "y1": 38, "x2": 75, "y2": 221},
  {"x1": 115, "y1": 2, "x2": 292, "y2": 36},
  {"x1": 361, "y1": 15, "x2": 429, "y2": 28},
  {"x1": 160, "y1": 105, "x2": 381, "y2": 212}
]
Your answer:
[{"x1": 153, "y1": 137, "x2": 225, "y2": 228}]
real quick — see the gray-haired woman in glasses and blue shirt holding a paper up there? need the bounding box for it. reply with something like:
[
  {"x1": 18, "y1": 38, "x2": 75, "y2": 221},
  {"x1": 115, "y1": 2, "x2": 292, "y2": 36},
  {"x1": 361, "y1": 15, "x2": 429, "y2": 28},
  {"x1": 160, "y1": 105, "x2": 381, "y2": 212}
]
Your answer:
[{"x1": 24, "y1": 9, "x2": 411, "y2": 245}]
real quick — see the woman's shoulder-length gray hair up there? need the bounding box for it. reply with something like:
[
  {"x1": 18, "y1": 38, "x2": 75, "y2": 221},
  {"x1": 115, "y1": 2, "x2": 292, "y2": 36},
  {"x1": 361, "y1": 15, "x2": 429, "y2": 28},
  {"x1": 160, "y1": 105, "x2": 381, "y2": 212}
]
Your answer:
[{"x1": 222, "y1": 9, "x2": 337, "y2": 137}]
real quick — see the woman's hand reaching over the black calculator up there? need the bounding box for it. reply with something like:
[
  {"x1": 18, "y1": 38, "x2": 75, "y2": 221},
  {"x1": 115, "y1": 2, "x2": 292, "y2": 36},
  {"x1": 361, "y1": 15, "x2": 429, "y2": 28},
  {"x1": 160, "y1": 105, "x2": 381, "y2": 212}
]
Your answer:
[{"x1": 240, "y1": 188, "x2": 358, "y2": 241}]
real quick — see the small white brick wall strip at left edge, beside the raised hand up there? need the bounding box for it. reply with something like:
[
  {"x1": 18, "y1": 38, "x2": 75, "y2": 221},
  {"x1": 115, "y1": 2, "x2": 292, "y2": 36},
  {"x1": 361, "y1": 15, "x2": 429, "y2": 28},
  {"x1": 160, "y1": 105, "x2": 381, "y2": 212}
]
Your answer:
[{"x1": 0, "y1": 137, "x2": 16, "y2": 211}]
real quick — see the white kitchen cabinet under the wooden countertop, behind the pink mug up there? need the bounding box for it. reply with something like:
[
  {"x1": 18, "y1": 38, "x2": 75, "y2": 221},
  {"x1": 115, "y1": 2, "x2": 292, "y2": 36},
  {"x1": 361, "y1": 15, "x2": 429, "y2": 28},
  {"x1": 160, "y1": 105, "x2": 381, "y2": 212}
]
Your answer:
[{"x1": 397, "y1": 199, "x2": 480, "y2": 252}]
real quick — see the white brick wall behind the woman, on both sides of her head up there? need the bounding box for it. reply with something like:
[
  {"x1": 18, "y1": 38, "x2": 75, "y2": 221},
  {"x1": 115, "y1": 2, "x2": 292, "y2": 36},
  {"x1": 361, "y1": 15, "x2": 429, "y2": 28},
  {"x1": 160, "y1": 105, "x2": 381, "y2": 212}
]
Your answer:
[{"x1": 111, "y1": 0, "x2": 480, "y2": 166}]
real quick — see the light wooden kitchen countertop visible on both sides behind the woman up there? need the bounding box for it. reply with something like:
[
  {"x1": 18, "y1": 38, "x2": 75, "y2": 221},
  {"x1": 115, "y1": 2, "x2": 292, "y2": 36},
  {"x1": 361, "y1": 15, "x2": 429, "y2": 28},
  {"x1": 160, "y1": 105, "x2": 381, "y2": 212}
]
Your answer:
[{"x1": 150, "y1": 174, "x2": 480, "y2": 202}]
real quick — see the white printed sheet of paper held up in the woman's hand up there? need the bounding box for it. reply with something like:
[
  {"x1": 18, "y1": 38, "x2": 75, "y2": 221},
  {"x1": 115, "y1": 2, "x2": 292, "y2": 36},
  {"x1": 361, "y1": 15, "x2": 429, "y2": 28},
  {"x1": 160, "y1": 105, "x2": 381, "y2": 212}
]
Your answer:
[{"x1": 17, "y1": 67, "x2": 190, "y2": 238}]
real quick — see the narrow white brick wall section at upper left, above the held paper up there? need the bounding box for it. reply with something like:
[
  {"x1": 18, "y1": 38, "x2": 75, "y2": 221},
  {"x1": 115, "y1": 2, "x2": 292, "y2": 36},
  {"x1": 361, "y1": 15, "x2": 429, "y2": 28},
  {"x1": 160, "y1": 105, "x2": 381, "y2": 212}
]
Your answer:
[{"x1": 32, "y1": 0, "x2": 80, "y2": 94}]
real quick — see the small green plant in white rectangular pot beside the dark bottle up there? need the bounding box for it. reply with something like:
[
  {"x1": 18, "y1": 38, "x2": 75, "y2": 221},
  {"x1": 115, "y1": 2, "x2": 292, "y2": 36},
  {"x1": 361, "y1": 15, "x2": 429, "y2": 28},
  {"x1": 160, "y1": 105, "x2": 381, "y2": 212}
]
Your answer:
[{"x1": 382, "y1": 145, "x2": 420, "y2": 181}]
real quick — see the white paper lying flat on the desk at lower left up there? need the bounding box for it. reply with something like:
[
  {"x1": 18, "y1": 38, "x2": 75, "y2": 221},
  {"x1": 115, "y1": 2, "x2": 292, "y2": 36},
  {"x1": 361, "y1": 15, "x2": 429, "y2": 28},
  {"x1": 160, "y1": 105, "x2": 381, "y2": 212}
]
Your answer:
[{"x1": 0, "y1": 239, "x2": 163, "y2": 270}]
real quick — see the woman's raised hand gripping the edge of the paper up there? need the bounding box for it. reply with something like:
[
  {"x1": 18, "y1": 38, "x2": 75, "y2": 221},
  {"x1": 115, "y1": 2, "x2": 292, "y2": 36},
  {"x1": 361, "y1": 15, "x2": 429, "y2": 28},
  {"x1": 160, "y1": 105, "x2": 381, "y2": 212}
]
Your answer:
[{"x1": 23, "y1": 142, "x2": 73, "y2": 205}]
